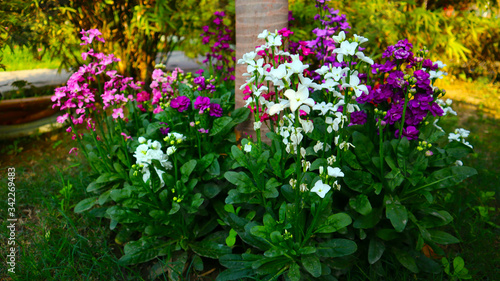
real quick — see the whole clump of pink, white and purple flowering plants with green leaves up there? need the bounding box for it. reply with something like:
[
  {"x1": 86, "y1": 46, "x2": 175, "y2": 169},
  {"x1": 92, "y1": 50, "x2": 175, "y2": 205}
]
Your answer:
[{"x1": 48, "y1": 1, "x2": 482, "y2": 280}]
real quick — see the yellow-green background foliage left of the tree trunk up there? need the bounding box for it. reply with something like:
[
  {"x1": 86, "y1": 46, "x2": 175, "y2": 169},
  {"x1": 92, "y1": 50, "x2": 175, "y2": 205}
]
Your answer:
[{"x1": 2, "y1": 0, "x2": 234, "y2": 84}]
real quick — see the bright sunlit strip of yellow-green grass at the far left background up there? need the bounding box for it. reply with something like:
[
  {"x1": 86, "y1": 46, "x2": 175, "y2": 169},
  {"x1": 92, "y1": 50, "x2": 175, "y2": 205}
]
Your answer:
[{"x1": 0, "y1": 46, "x2": 61, "y2": 71}]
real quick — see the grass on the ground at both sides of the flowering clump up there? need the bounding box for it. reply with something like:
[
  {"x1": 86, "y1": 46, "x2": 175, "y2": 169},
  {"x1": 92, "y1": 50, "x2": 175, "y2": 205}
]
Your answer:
[{"x1": 0, "y1": 76, "x2": 500, "y2": 281}]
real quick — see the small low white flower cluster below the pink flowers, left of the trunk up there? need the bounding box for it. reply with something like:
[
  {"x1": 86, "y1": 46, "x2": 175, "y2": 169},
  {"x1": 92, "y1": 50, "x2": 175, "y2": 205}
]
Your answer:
[{"x1": 134, "y1": 137, "x2": 172, "y2": 187}]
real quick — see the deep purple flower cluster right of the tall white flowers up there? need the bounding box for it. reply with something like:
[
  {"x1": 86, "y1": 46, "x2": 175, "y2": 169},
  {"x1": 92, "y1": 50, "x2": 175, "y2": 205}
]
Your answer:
[{"x1": 357, "y1": 39, "x2": 444, "y2": 140}]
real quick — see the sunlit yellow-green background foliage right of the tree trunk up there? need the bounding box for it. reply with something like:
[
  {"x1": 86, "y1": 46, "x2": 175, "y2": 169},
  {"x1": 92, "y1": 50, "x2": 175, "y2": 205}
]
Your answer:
[{"x1": 290, "y1": 0, "x2": 500, "y2": 80}]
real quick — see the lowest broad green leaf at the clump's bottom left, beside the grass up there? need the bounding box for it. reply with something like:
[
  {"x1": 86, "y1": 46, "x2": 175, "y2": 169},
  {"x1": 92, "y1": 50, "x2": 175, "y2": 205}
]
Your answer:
[{"x1": 118, "y1": 237, "x2": 171, "y2": 265}]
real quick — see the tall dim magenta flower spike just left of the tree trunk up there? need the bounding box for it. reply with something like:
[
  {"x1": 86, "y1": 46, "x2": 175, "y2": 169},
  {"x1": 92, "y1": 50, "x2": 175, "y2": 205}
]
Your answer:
[{"x1": 201, "y1": 12, "x2": 236, "y2": 81}]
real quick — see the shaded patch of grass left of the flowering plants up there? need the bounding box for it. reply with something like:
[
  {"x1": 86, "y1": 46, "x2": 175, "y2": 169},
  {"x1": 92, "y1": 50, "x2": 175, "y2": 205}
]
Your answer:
[{"x1": 0, "y1": 132, "x2": 148, "y2": 280}]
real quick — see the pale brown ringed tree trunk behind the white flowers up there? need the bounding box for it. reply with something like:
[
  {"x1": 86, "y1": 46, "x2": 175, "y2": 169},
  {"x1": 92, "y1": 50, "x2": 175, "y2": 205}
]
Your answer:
[{"x1": 235, "y1": 0, "x2": 288, "y2": 140}]
